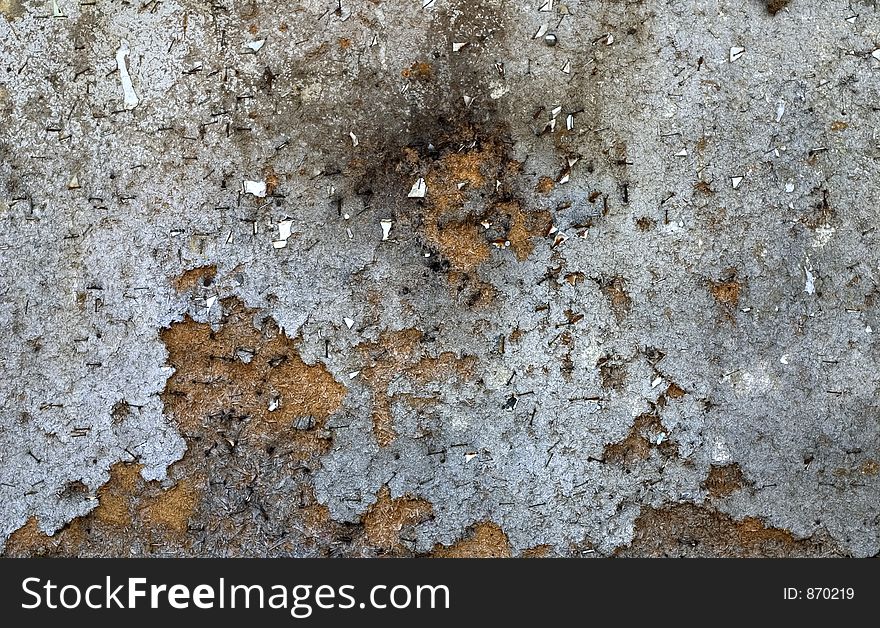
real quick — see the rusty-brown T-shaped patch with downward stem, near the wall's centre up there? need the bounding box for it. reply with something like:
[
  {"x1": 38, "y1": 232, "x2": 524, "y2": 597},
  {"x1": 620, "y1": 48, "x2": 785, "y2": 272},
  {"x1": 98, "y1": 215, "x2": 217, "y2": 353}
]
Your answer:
[{"x1": 358, "y1": 329, "x2": 476, "y2": 447}]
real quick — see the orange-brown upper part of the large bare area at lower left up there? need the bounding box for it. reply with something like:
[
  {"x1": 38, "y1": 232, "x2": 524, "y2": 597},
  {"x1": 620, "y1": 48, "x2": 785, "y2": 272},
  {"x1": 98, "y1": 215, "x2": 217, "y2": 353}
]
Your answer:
[{"x1": 159, "y1": 298, "x2": 346, "y2": 433}]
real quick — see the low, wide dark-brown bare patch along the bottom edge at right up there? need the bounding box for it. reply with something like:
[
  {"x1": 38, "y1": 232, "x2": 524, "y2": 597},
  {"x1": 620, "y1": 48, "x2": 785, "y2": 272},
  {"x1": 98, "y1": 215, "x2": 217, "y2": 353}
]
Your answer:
[{"x1": 615, "y1": 504, "x2": 841, "y2": 558}]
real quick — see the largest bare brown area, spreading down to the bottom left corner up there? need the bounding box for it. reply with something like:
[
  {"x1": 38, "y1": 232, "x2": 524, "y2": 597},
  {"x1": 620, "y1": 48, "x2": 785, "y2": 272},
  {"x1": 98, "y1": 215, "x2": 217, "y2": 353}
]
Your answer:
[{"x1": 5, "y1": 272, "x2": 364, "y2": 556}]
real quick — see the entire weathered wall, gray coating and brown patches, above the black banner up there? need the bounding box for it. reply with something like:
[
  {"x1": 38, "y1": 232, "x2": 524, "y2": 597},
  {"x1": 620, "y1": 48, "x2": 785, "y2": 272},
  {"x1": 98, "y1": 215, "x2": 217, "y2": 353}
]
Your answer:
[{"x1": 0, "y1": 0, "x2": 880, "y2": 557}]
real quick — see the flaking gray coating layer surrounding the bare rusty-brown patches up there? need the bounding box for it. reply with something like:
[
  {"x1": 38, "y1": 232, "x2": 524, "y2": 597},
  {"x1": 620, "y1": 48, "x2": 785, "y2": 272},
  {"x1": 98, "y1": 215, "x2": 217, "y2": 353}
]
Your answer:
[{"x1": 0, "y1": 0, "x2": 880, "y2": 556}]
